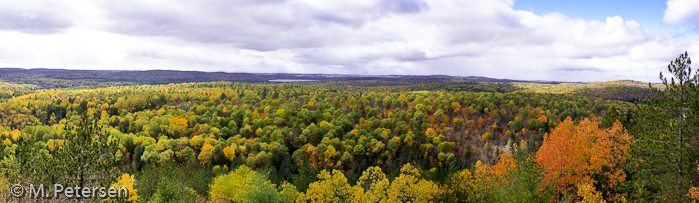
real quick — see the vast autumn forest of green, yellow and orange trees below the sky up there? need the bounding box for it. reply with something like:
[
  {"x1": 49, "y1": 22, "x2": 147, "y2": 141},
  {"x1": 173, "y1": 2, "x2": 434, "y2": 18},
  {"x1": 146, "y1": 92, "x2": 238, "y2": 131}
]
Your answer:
[{"x1": 0, "y1": 53, "x2": 699, "y2": 202}]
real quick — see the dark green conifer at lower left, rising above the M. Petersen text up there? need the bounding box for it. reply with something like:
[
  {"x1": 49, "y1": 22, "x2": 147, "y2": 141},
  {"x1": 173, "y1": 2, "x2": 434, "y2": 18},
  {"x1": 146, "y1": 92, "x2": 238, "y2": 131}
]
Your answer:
[{"x1": 50, "y1": 114, "x2": 119, "y2": 193}]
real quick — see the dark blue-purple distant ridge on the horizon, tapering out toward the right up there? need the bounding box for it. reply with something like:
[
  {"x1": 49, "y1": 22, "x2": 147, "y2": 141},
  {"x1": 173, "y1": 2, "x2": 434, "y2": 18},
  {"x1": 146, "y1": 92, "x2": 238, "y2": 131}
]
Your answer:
[{"x1": 0, "y1": 68, "x2": 556, "y2": 86}]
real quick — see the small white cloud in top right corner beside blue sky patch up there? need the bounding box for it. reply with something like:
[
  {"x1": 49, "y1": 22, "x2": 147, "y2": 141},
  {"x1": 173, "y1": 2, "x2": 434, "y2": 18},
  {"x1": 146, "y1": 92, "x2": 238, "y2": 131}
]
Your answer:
[{"x1": 663, "y1": 0, "x2": 699, "y2": 26}]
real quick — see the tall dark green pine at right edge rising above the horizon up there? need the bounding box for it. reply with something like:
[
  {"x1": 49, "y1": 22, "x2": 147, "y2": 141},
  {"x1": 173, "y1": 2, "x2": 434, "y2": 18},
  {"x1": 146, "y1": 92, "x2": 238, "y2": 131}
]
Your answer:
[{"x1": 633, "y1": 52, "x2": 699, "y2": 202}]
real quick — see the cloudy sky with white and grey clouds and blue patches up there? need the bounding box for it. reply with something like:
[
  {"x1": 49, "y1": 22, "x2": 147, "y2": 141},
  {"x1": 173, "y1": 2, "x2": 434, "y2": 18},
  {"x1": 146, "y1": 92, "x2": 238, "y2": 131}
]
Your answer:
[{"x1": 0, "y1": 0, "x2": 699, "y2": 82}]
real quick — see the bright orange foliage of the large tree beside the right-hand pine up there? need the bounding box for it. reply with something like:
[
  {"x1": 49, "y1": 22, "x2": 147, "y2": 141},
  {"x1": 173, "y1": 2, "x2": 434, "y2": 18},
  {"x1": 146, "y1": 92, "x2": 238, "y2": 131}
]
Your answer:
[{"x1": 536, "y1": 118, "x2": 632, "y2": 194}]
